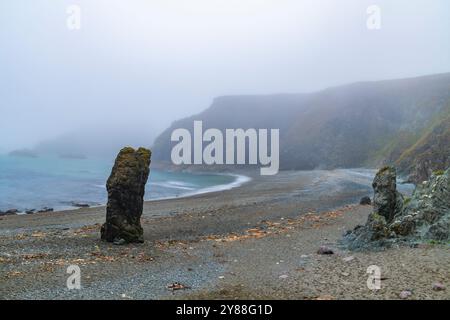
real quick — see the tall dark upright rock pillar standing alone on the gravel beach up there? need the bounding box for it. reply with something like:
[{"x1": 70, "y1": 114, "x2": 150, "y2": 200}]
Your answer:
[{"x1": 101, "y1": 147, "x2": 151, "y2": 244}]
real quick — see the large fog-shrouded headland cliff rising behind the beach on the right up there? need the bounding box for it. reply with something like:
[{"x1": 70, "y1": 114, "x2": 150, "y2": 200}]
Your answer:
[{"x1": 153, "y1": 73, "x2": 450, "y2": 181}]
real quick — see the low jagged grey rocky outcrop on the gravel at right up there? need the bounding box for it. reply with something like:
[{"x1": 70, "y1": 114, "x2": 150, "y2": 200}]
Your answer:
[{"x1": 344, "y1": 167, "x2": 450, "y2": 249}]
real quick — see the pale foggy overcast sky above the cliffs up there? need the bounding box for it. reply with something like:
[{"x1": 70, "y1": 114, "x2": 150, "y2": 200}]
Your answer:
[{"x1": 0, "y1": 0, "x2": 450, "y2": 152}]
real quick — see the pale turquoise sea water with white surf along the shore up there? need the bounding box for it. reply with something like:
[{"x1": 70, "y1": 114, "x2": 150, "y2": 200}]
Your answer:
[{"x1": 0, "y1": 155, "x2": 243, "y2": 211}]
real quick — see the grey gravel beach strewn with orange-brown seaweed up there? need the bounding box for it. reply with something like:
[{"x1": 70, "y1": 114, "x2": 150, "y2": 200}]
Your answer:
[{"x1": 0, "y1": 170, "x2": 450, "y2": 299}]
